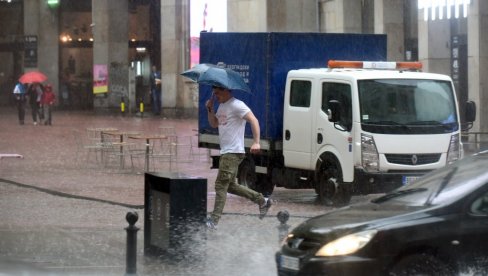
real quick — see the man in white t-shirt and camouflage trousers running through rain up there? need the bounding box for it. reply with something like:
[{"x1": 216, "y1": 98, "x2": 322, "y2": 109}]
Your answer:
[{"x1": 202, "y1": 86, "x2": 272, "y2": 229}]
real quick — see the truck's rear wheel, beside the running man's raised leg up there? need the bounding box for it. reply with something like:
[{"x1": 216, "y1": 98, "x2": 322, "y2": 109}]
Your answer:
[{"x1": 237, "y1": 158, "x2": 274, "y2": 197}]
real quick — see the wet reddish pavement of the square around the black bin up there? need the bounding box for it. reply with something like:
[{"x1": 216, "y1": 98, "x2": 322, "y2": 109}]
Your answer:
[{"x1": 0, "y1": 107, "x2": 336, "y2": 275}]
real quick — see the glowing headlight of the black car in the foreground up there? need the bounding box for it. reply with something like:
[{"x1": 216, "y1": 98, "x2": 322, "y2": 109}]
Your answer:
[{"x1": 315, "y1": 230, "x2": 378, "y2": 257}]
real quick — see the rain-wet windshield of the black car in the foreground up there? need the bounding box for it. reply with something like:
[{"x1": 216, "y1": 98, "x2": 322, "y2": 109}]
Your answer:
[{"x1": 373, "y1": 154, "x2": 488, "y2": 206}]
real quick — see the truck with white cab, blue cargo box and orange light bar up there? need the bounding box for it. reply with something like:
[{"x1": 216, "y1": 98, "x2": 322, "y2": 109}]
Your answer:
[{"x1": 195, "y1": 33, "x2": 475, "y2": 205}]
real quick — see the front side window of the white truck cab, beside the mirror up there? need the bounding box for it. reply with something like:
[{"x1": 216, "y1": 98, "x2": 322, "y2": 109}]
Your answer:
[{"x1": 322, "y1": 82, "x2": 352, "y2": 130}]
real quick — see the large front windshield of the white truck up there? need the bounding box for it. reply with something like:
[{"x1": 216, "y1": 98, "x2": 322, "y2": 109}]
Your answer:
[{"x1": 358, "y1": 79, "x2": 458, "y2": 134}]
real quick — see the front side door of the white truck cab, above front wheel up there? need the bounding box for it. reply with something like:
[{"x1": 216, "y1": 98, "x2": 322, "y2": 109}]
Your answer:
[{"x1": 313, "y1": 81, "x2": 354, "y2": 182}]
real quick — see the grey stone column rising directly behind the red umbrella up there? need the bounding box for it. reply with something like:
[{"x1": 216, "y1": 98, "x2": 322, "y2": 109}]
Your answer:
[{"x1": 24, "y1": 0, "x2": 59, "y2": 97}]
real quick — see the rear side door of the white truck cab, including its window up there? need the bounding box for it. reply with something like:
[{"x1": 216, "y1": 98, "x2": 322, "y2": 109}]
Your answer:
[{"x1": 283, "y1": 79, "x2": 316, "y2": 170}]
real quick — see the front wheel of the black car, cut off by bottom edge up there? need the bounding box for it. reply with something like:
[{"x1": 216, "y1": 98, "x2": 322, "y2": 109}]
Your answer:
[{"x1": 390, "y1": 254, "x2": 456, "y2": 276}]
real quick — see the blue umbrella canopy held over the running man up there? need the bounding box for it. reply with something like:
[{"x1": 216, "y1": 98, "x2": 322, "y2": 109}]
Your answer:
[{"x1": 181, "y1": 63, "x2": 251, "y2": 93}]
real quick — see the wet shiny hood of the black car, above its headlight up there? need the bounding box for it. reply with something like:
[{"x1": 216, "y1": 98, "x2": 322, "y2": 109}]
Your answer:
[{"x1": 293, "y1": 202, "x2": 429, "y2": 236}]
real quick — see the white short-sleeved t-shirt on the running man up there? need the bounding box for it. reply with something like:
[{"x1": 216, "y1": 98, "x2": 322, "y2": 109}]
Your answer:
[{"x1": 215, "y1": 98, "x2": 251, "y2": 154}]
